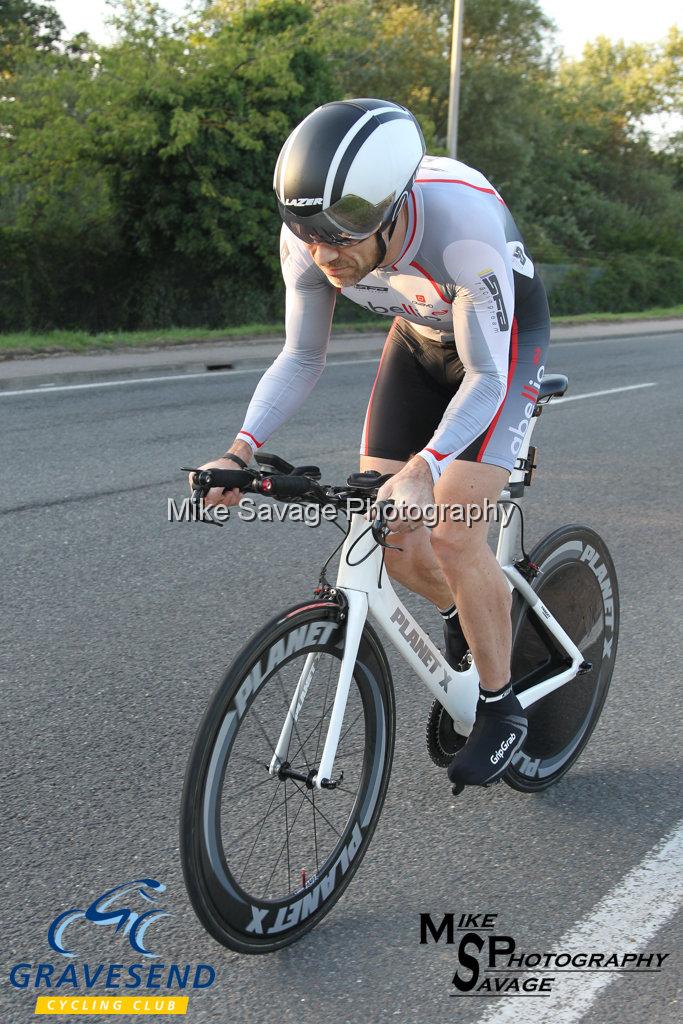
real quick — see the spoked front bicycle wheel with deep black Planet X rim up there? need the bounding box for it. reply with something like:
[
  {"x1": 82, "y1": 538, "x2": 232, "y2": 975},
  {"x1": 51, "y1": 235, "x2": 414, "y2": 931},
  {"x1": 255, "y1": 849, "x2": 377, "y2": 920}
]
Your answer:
[{"x1": 180, "y1": 601, "x2": 395, "y2": 953}]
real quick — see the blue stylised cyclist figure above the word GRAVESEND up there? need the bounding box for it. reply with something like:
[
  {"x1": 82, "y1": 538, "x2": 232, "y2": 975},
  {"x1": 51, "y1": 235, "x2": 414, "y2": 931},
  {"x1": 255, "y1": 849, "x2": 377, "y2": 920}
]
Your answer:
[{"x1": 47, "y1": 879, "x2": 169, "y2": 956}]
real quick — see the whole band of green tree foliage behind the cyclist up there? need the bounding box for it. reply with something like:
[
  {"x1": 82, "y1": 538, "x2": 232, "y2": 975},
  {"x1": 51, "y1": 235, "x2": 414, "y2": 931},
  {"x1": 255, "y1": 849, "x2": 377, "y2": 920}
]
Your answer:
[{"x1": 0, "y1": 0, "x2": 683, "y2": 330}]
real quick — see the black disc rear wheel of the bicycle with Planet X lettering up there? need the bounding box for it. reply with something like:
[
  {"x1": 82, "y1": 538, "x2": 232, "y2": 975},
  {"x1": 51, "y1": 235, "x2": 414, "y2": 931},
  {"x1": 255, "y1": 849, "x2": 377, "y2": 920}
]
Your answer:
[{"x1": 503, "y1": 525, "x2": 620, "y2": 793}]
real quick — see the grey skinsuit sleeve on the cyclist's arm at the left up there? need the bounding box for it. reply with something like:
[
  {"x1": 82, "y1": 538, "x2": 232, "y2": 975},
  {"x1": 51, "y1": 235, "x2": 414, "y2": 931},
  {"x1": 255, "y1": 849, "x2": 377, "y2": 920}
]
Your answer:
[{"x1": 238, "y1": 227, "x2": 337, "y2": 451}]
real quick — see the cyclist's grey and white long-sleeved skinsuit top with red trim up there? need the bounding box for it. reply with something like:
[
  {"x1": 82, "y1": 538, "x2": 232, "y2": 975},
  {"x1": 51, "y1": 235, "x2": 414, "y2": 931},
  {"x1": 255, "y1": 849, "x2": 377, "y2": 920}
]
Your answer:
[{"x1": 239, "y1": 157, "x2": 547, "y2": 478}]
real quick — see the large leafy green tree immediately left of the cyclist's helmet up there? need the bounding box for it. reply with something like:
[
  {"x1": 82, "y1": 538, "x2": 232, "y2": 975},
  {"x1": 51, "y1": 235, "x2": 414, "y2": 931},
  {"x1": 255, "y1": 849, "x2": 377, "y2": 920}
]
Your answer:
[{"x1": 91, "y1": 0, "x2": 330, "y2": 323}]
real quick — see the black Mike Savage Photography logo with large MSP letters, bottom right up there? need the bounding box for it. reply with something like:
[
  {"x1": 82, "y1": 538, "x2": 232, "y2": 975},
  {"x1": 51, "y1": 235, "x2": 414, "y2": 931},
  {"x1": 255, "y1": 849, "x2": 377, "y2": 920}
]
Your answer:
[{"x1": 420, "y1": 913, "x2": 670, "y2": 995}]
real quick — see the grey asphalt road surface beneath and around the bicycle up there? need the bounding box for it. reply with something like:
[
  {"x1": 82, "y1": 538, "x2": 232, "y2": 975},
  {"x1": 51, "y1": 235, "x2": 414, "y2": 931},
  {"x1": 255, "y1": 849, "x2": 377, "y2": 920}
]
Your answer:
[{"x1": 0, "y1": 334, "x2": 683, "y2": 1024}]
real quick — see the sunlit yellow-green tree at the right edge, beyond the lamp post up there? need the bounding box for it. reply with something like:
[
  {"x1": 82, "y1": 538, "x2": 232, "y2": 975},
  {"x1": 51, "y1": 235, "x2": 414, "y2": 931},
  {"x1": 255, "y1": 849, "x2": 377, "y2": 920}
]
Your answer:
[{"x1": 555, "y1": 30, "x2": 683, "y2": 257}]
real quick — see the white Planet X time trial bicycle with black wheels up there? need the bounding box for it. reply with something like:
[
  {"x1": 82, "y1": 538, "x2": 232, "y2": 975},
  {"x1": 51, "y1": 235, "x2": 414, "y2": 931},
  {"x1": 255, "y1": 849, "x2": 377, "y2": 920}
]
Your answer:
[{"x1": 180, "y1": 375, "x2": 620, "y2": 953}]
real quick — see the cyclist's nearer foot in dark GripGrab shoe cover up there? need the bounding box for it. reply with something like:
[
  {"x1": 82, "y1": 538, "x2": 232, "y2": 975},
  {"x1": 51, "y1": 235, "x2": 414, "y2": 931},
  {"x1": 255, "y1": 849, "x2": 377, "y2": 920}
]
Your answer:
[{"x1": 447, "y1": 685, "x2": 527, "y2": 786}]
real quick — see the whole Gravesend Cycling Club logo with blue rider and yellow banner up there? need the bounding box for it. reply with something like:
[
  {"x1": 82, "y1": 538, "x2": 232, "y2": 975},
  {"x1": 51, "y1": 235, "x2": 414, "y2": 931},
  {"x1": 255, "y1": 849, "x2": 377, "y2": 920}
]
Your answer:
[{"x1": 8, "y1": 879, "x2": 216, "y2": 1015}]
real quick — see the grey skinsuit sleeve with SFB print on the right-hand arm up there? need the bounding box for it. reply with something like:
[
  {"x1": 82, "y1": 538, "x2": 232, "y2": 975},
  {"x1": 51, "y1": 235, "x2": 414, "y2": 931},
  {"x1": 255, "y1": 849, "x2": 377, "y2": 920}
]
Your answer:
[{"x1": 418, "y1": 240, "x2": 514, "y2": 482}]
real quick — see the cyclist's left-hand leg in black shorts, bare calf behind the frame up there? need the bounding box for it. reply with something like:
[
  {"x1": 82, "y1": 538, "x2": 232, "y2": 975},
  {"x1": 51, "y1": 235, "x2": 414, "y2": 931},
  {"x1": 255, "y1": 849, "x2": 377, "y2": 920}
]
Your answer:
[{"x1": 360, "y1": 317, "x2": 453, "y2": 609}]
